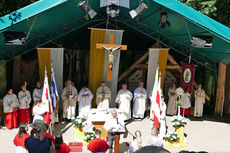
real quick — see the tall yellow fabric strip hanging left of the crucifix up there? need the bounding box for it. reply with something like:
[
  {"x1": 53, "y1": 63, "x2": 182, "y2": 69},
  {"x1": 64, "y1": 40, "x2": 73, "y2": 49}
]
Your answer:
[{"x1": 89, "y1": 29, "x2": 106, "y2": 107}]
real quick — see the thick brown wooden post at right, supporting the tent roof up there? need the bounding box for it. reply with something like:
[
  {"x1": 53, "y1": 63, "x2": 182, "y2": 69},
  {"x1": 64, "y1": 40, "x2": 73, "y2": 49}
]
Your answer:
[{"x1": 215, "y1": 63, "x2": 226, "y2": 117}]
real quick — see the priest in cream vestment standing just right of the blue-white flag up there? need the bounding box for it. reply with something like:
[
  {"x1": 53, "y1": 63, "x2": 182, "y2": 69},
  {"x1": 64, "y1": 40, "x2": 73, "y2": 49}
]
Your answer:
[{"x1": 61, "y1": 80, "x2": 78, "y2": 120}]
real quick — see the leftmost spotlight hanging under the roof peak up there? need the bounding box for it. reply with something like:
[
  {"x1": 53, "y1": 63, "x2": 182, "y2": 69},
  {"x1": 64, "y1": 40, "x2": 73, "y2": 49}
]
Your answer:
[{"x1": 78, "y1": 0, "x2": 97, "y2": 20}]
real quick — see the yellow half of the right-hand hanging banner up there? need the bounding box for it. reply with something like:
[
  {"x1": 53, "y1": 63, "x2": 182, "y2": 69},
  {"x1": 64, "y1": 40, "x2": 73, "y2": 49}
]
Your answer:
[{"x1": 158, "y1": 48, "x2": 169, "y2": 89}]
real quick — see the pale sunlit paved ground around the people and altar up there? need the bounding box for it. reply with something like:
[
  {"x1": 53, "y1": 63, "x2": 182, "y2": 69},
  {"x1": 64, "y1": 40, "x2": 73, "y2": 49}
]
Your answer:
[{"x1": 0, "y1": 117, "x2": 230, "y2": 153}]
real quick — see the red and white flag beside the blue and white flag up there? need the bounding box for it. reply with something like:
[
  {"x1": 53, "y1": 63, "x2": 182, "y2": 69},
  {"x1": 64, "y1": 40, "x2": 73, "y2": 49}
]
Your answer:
[{"x1": 42, "y1": 68, "x2": 52, "y2": 124}]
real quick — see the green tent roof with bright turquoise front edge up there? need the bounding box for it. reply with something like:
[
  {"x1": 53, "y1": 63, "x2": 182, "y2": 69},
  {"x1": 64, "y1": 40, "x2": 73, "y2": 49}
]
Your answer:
[{"x1": 0, "y1": 0, "x2": 230, "y2": 69}]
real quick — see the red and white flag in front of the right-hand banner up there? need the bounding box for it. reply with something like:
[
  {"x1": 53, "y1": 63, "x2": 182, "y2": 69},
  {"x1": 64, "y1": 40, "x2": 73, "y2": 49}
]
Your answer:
[{"x1": 153, "y1": 73, "x2": 161, "y2": 127}]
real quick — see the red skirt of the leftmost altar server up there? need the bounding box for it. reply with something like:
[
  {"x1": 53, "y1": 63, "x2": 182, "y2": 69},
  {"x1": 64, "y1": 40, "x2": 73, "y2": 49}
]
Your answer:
[{"x1": 4, "y1": 108, "x2": 18, "y2": 129}]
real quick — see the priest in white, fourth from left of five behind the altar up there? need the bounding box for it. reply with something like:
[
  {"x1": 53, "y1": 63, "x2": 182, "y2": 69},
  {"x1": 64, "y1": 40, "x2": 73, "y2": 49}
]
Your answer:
[{"x1": 115, "y1": 84, "x2": 133, "y2": 120}]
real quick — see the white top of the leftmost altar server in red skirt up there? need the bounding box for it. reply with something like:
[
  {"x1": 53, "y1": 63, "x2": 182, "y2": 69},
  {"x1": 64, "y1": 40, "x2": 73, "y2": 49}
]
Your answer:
[{"x1": 3, "y1": 94, "x2": 19, "y2": 113}]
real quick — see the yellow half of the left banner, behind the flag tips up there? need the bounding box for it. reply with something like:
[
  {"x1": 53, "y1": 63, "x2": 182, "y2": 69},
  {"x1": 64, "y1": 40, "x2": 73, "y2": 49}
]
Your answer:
[{"x1": 37, "y1": 48, "x2": 51, "y2": 82}]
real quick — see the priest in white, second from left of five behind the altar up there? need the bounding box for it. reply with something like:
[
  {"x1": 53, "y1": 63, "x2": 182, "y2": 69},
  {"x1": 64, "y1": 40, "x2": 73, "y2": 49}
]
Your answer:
[{"x1": 78, "y1": 87, "x2": 93, "y2": 119}]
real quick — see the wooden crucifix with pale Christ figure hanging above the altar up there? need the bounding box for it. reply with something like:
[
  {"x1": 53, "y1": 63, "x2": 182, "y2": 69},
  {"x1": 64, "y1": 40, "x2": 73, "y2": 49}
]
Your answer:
[{"x1": 96, "y1": 34, "x2": 127, "y2": 81}]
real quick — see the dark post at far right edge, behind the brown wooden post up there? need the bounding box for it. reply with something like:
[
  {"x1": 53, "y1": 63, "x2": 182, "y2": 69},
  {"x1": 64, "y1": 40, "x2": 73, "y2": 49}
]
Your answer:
[{"x1": 224, "y1": 66, "x2": 230, "y2": 115}]
